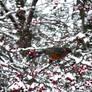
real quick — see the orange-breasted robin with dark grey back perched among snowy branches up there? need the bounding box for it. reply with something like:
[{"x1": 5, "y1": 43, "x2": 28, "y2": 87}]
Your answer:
[{"x1": 39, "y1": 47, "x2": 71, "y2": 60}]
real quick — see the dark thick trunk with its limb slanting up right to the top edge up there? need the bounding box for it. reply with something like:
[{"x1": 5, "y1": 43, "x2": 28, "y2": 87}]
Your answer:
[{"x1": 16, "y1": 0, "x2": 38, "y2": 49}]
